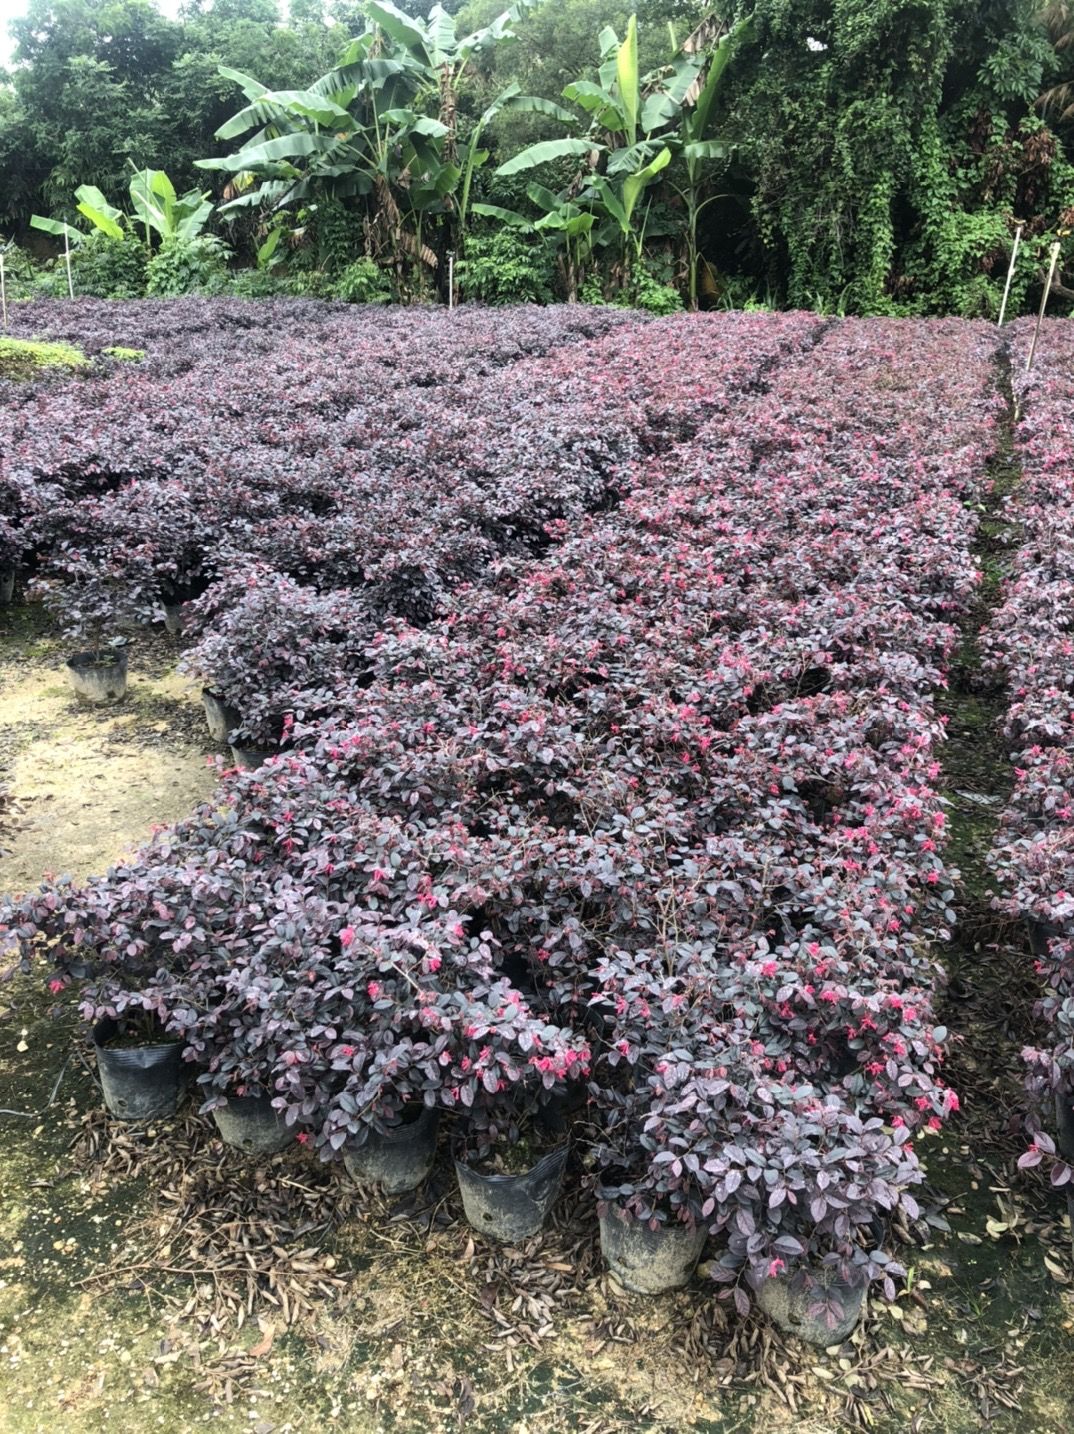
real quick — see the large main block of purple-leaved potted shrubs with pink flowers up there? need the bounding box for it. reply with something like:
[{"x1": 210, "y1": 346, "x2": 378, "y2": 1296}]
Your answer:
[{"x1": 0, "y1": 301, "x2": 1003, "y2": 1329}]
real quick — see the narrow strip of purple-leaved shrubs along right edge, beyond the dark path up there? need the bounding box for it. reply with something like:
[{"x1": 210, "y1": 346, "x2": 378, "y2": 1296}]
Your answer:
[{"x1": 985, "y1": 324, "x2": 1074, "y2": 1186}]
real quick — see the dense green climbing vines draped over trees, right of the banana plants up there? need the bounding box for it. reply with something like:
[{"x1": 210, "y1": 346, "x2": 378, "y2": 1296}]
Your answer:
[{"x1": 726, "y1": 0, "x2": 1074, "y2": 315}]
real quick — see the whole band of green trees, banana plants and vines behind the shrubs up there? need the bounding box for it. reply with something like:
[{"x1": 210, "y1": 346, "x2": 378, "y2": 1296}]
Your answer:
[{"x1": 0, "y1": 0, "x2": 1074, "y2": 315}]
